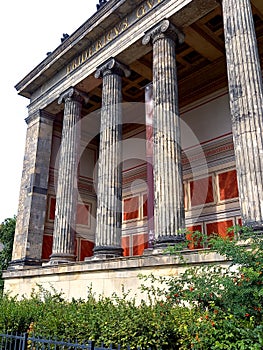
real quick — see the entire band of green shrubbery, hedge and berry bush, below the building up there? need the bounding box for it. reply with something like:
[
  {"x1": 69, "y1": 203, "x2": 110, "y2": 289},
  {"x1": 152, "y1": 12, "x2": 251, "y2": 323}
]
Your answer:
[{"x1": 0, "y1": 228, "x2": 263, "y2": 350}]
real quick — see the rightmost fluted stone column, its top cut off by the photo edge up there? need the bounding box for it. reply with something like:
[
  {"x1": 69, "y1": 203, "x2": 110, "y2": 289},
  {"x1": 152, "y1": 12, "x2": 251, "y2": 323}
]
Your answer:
[{"x1": 222, "y1": 0, "x2": 263, "y2": 230}]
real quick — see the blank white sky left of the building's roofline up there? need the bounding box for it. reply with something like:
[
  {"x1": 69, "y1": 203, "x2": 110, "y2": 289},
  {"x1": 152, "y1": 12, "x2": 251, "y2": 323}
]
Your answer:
[{"x1": 0, "y1": 0, "x2": 99, "y2": 223}]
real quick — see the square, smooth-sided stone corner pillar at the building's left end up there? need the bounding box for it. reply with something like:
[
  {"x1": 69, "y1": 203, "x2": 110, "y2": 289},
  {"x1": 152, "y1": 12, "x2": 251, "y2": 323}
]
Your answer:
[{"x1": 10, "y1": 110, "x2": 54, "y2": 268}]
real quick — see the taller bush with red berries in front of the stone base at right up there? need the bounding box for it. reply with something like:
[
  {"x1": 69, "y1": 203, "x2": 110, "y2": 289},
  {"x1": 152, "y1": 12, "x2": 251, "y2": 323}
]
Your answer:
[{"x1": 166, "y1": 228, "x2": 263, "y2": 323}]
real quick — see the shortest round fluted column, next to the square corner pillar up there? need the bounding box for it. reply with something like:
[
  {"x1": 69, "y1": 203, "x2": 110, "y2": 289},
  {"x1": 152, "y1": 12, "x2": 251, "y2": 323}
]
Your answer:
[{"x1": 50, "y1": 88, "x2": 88, "y2": 263}]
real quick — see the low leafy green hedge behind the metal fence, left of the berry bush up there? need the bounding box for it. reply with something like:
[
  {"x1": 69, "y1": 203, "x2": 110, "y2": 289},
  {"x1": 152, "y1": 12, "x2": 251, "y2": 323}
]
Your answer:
[{"x1": 0, "y1": 290, "x2": 192, "y2": 349}]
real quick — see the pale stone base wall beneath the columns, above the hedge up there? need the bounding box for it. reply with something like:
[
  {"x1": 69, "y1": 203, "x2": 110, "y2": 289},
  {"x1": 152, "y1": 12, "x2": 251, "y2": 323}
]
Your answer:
[{"x1": 4, "y1": 251, "x2": 229, "y2": 303}]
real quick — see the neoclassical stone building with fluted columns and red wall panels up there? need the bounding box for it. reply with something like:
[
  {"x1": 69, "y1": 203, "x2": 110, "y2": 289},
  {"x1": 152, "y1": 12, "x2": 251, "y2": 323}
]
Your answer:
[{"x1": 4, "y1": 0, "x2": 263, "y2": 297}]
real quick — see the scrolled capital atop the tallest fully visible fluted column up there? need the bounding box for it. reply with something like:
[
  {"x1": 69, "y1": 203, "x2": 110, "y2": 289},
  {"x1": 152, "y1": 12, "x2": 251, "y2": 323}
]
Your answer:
[{"x1": 142, "y1": 19, "x2": 184, "y2": 45}]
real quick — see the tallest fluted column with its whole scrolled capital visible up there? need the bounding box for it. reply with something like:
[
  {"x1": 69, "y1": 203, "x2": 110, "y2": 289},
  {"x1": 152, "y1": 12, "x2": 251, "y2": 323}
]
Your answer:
[{"x1": 143, "y1": 20, "x2": 185, "y2": 248}]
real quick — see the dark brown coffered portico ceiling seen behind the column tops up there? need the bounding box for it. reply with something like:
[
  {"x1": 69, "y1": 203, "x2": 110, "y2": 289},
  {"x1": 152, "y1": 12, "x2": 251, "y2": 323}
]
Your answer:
[{"x1": 75, "y1": 0, "x2": 263, "y2": 115}]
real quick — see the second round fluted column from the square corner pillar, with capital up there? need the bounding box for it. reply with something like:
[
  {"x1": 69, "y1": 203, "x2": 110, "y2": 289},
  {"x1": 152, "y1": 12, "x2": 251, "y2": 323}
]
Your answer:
[{"x1": 94, "y1": 58, "x2": 129, "y2": 258}]
